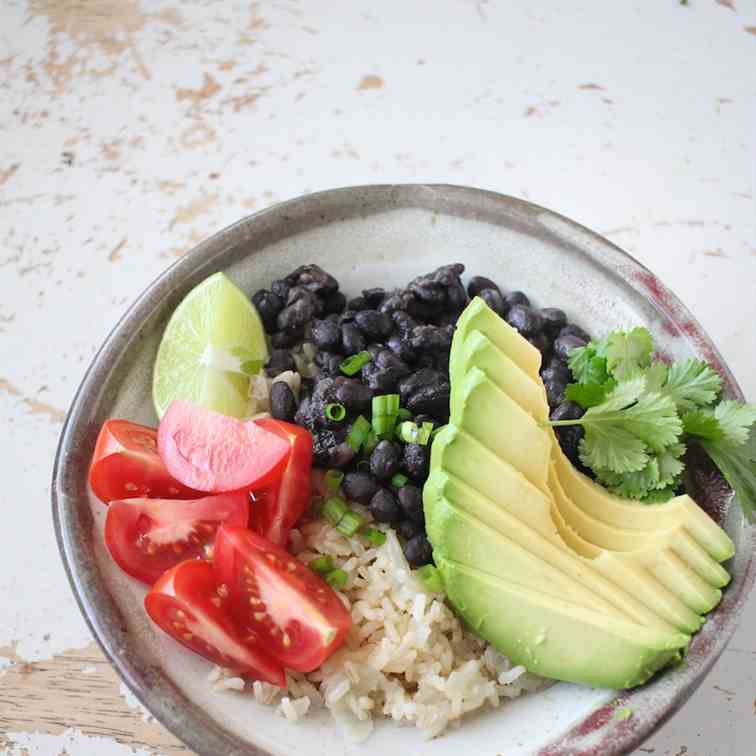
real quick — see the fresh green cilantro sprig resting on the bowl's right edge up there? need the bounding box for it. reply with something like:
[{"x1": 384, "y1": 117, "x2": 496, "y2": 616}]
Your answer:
[{"x1": 550, "y1": 328, "x2": 756, "y2": 519}]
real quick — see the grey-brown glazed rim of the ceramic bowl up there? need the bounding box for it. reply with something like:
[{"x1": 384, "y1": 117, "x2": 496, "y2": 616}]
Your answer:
[{"x1": 51, "y1": 183, "x2": 756, "y2": 756}]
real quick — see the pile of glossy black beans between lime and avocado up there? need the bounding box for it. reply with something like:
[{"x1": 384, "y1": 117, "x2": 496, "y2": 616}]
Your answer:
[{"x1": 252, "y1": 263, "x2": 590, "y2": 567}]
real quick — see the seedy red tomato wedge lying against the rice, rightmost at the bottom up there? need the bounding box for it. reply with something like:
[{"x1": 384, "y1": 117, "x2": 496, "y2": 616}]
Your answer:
[{"x1": 213, "y1": 525, "x2": 352, "y2": 672}]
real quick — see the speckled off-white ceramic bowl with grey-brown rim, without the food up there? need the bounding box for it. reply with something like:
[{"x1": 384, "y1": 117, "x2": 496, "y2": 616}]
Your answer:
[{"x1": 52, "y1": 185, "x2": 755, "y2": 756}]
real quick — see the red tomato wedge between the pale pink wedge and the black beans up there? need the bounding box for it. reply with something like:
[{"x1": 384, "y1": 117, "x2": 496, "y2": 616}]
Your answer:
[{"x1": 251, "y1": 418, "x2": 312, "y2": 546}]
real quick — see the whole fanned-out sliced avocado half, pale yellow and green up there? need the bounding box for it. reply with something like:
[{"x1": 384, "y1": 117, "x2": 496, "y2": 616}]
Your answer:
[{"x1": 424, "y1": 301, "x2": 733, "y2": 687}]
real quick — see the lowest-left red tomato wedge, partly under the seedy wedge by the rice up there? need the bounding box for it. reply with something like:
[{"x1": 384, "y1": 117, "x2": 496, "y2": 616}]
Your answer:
[{"x1": 144, "y1": 560, "x2": 286, "y2": 687}]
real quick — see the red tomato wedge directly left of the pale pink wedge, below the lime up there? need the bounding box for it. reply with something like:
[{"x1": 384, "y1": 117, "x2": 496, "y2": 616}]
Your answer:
[{"x1": 89, "y1": 420, "x2": 202, "y2": 504}]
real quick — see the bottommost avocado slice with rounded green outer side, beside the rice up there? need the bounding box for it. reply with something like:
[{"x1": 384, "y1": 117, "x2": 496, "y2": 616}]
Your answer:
[{"x1": 436, "y1": 556, "x2": 690, "y2": 688}]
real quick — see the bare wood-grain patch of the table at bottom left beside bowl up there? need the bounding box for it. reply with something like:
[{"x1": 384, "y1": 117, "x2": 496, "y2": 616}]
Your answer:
[{"x1": 0, "y1": 643, "x2": 192, "y2": 756}]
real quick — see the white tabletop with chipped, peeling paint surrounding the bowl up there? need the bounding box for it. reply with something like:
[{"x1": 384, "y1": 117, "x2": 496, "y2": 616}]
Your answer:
[{"x1": 0, "y1": 0, "x2": 756, "y2": 756}]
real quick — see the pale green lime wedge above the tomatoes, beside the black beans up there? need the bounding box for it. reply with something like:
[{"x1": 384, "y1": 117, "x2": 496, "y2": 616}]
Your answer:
[{"x1": 152, "y1": 273, "x2": 268, "y2": 417}]
